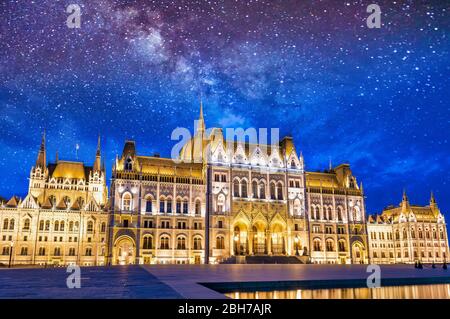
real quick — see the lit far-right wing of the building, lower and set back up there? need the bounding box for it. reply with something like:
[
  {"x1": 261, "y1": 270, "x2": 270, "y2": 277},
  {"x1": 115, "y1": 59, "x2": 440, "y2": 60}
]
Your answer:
[{"x1": 367, "y1": 193, "x2": 449, "y2": 264}]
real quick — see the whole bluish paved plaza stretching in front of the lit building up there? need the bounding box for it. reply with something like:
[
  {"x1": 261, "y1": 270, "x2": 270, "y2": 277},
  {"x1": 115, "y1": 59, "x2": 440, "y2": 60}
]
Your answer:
[{"x1": 0, "y1": 264, "x2": 450, "y2": 299}]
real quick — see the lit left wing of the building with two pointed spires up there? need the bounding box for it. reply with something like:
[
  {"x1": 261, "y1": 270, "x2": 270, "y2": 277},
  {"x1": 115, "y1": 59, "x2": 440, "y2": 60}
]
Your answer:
[{"x1": 0, "y1": 135, "x2": 108, "y2": 266}]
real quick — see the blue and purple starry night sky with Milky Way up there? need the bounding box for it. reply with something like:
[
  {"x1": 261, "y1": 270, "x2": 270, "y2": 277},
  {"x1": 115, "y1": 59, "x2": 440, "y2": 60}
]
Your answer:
[{"x1": 0, "y1": 0, "x2": 450, "y2": 218}]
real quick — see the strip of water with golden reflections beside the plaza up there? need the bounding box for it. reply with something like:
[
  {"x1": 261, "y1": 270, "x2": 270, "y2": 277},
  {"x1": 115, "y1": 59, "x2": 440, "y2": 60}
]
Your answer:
[{"x1": 225, "y1": 284, "x2": 450, "y2": 299}]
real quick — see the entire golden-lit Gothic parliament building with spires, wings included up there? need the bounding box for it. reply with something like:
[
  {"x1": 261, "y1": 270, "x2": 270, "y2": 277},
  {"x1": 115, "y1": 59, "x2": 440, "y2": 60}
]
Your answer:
[{"x1": 0, "y1": 110, "x2": 449, "y2": 266}]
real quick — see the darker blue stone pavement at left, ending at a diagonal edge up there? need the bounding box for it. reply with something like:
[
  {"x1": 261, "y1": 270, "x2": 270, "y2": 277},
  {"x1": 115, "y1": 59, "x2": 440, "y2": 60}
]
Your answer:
[{"x1": 0, "y1": 266, "x2": 181, "y2": 299}]
